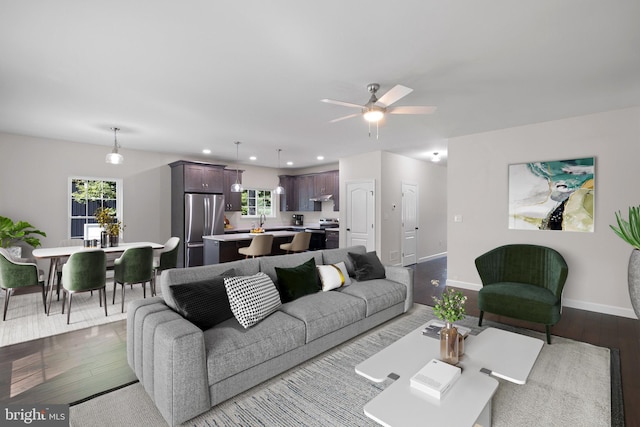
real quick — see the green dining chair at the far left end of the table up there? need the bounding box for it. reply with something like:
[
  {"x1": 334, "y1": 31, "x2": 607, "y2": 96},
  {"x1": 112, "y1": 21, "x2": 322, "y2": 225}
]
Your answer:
[{"x1": 0, "y1": 248, "x2": 47, "y2": 321}]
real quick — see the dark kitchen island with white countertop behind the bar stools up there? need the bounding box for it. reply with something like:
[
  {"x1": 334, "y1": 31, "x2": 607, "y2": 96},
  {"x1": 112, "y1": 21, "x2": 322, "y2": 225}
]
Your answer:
[{"x1": 203, "y1": 230, "x2": 297, "y2": 265}]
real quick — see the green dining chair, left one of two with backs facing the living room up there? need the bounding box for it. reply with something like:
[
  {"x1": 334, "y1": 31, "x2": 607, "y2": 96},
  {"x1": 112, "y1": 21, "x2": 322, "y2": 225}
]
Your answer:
[{"x1": 62, "y1": 249, "x2": 107, "y2": 325}]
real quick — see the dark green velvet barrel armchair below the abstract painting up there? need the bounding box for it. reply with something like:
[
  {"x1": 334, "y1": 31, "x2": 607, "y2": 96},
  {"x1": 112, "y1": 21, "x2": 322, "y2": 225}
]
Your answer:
[{"x1": 476, "y1": 244, "x2": 569, "y2": 344}]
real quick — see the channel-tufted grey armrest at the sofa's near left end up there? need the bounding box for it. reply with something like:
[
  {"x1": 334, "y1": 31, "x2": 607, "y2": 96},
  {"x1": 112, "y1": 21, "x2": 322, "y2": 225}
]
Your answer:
[{"x1": 127, "y1": 298, "x2": 211, "y2": 425}]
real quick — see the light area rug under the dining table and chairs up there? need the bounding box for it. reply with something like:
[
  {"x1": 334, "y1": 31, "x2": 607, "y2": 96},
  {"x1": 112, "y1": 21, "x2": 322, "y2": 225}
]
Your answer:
[{"x1": 0, "y1": 280, "x2": 160, "y2": 347}]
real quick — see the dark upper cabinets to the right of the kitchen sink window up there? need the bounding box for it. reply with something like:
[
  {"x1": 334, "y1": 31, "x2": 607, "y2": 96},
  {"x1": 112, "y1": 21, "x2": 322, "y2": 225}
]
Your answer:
[{"x1": 280, "y1": 171, "x2": 340, "y2": 212}]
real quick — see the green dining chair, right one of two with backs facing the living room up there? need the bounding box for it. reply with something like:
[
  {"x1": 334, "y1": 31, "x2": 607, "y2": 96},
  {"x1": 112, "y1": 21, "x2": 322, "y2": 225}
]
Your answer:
[{"x1": 112, "y1": 246, "x2": 153, "y2": 313}]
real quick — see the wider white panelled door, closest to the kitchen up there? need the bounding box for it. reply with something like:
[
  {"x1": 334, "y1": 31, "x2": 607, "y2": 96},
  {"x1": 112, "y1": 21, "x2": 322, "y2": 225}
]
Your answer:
[{"x1": 346, "y1": 181, "x2": 376, "y2": 251}]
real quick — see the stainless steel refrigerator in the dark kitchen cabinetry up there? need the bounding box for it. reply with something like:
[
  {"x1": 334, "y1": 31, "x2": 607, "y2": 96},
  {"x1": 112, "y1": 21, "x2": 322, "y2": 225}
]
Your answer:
[{"x1": 184, "y1": 193, "x2": 224, "y2": 267}]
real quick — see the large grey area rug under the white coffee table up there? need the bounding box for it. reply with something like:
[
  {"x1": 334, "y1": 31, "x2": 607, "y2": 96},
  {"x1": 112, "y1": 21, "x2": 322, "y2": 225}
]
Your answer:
[{"x1": 70, "y1": 304, "x2": 624, "y2": 427}]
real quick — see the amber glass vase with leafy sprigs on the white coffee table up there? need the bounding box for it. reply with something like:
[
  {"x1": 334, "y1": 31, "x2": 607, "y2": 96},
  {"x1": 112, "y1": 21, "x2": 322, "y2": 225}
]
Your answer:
[{"x1": 433, "y1": 289, "x2": 467, "y2": 365}]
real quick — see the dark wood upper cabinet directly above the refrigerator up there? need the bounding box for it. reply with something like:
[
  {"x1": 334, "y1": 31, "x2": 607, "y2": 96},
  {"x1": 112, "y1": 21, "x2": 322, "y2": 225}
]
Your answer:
[{"x1": 169, "y1": 160, "x2": 224, "y2": 194}]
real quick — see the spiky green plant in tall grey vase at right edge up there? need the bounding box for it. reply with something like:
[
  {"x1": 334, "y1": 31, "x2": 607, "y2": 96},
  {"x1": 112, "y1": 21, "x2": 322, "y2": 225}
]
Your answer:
[{"x1": 610, "y1": 206, "x2": 640, "y2": 319}]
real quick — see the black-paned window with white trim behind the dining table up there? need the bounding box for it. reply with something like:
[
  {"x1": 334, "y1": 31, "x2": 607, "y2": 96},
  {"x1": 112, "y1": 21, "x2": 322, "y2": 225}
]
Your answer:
[{"x1": 69, "y1": 177, "x2": 122, "y2": 239}]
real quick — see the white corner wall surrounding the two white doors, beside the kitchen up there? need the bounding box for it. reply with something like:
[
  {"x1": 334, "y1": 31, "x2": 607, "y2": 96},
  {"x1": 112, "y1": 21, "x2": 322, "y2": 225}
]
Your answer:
[{"x1": 340, "y1": 151, "x2": 447, "y2": 264}]
